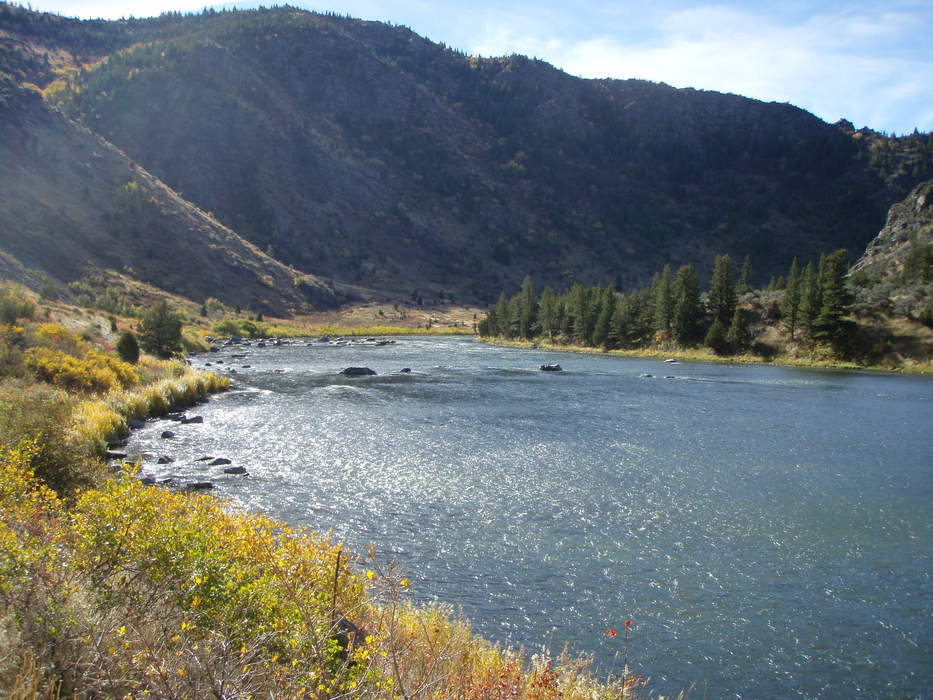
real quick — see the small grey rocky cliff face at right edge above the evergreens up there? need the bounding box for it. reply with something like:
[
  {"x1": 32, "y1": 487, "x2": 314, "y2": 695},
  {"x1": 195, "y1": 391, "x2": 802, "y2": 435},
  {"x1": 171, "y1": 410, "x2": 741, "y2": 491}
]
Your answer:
[{"x1": 852, "y1": 180, "x2": 933, "y2": 279}]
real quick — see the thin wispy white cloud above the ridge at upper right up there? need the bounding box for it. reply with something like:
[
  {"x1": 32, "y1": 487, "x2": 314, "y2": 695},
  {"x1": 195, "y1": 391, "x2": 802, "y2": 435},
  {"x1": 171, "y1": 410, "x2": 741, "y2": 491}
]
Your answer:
[{"x1": 472, "y1": 5, "x2": 933, "y2": 132}]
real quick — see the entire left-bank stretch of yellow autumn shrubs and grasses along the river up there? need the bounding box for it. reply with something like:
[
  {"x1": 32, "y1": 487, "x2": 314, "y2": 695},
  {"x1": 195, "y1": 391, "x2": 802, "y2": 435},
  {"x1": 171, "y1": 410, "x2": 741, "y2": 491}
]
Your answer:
[{"x1": 0, "y1": 286, "x2": 656, "y2": 700}]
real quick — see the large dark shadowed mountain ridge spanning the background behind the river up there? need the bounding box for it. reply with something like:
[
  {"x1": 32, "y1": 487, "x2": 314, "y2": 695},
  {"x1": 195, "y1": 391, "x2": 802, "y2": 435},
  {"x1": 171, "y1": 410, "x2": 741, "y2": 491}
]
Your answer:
[{"x1": 0, "y1": 5, "x2": 933, "y2": 302}]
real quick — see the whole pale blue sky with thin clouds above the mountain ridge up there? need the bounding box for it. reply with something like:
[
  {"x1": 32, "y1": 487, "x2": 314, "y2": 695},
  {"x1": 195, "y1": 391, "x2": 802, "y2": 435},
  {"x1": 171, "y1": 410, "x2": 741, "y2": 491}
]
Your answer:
[{"x1": 25, "y1": 0, "x2": 933, "y2": 134}]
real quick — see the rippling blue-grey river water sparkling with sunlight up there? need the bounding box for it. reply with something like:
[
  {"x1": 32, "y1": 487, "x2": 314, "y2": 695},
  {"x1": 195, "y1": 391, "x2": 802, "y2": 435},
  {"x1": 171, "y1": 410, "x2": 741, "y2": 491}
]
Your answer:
[{"x1": 130, "y1": 338, "x2": 933, "y2": 698}]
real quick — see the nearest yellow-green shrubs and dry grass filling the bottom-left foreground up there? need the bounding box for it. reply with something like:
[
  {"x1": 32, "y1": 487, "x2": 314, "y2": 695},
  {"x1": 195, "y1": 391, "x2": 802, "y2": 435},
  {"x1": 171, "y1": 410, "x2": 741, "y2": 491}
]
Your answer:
[{"x1": 0, "y1": 452, "x2": 656, "y2": 700}]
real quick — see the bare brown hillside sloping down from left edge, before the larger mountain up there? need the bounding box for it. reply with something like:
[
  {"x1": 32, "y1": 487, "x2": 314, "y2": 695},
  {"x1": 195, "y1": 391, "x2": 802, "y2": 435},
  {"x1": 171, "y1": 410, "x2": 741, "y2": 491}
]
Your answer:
[{"x1": 0, "y1": 61, "x2": 338, "y2": 315}]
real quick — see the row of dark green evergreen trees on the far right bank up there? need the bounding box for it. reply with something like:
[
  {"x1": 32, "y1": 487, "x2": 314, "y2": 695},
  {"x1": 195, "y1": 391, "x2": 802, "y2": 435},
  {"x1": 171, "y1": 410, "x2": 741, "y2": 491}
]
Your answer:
[{"x1": 478, "y1": 249, "x2": 854, "y2": 354}]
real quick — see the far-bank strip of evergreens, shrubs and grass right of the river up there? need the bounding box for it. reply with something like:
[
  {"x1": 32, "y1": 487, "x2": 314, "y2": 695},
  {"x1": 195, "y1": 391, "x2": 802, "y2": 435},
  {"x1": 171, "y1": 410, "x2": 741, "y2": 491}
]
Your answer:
[{"x1": 479, "y1": 245, "x2": 933, "y2": 370}]
